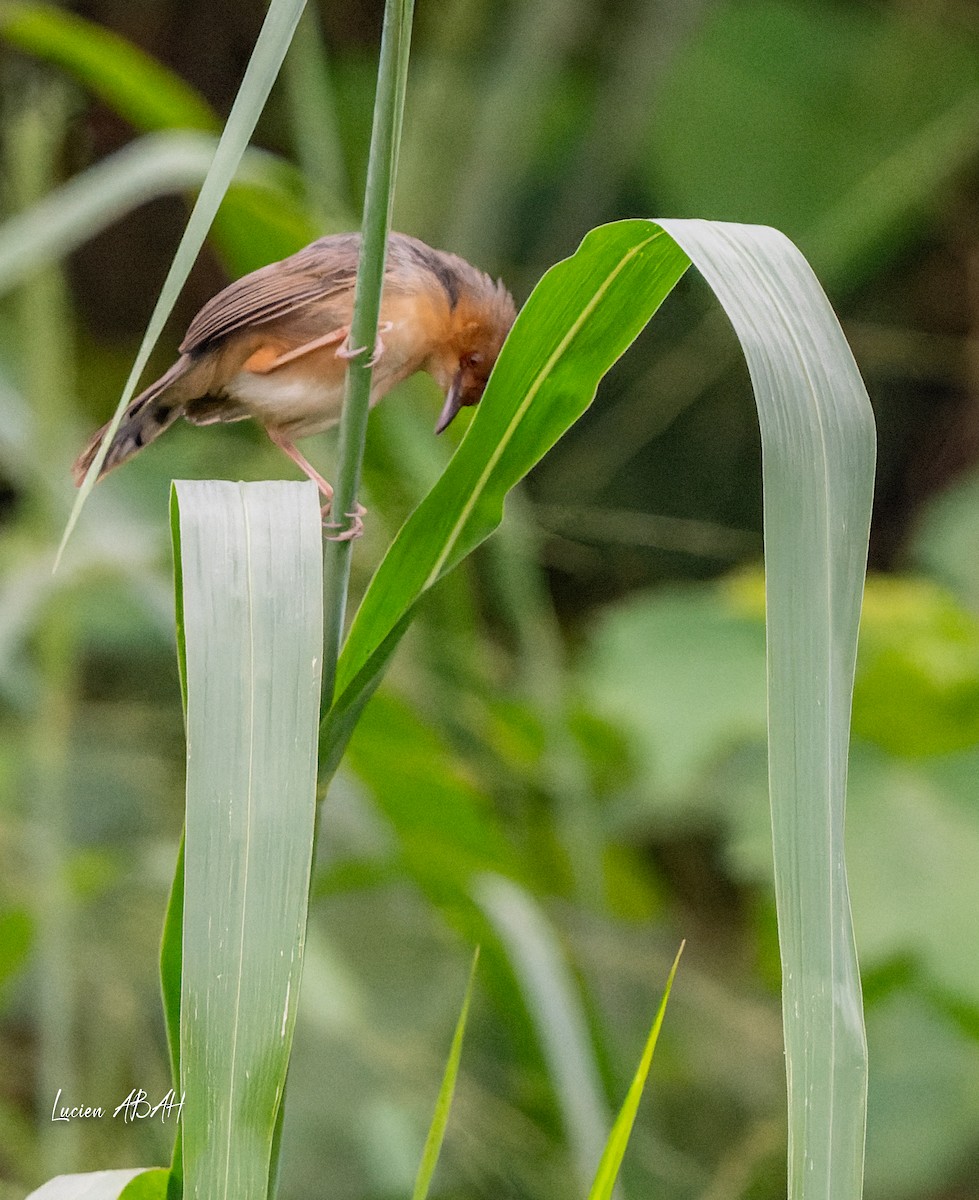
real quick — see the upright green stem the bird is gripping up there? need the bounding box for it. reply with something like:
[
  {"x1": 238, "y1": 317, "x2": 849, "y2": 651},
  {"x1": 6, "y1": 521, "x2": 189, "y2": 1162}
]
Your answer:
[{"x1": 323, "y1": 0, "x2": 414, "y2": 708}]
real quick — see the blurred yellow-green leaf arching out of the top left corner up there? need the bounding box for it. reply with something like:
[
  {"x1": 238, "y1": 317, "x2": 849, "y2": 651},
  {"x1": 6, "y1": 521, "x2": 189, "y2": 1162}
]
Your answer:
[{"x1": 0, "y1": 0, "x2": 220, "y2": 133}]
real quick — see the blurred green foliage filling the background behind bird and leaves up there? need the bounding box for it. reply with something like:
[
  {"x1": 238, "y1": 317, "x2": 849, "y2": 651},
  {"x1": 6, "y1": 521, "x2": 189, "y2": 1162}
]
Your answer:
[{"x1": 0, "y1": 0, "x2": 979, "y2": 1200}]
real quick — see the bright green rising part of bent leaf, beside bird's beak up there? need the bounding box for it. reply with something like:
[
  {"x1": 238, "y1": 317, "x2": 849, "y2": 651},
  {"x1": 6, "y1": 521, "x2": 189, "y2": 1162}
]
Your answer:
[{"x1": 324, "y1": 221, "x2": 687, "y2": 758}]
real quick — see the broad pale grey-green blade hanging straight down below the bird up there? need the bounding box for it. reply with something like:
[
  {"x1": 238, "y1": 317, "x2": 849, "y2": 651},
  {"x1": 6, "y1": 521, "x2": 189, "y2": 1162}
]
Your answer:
[{"x1": 175, "y1": 481, "x2": 323, "y2": 1200}]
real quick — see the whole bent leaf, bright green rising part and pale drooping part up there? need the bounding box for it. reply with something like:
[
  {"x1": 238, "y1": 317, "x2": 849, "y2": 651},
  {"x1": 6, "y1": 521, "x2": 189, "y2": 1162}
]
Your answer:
[{"x1": 322, "y1": 221, "x2": 876, "y2": 1200}]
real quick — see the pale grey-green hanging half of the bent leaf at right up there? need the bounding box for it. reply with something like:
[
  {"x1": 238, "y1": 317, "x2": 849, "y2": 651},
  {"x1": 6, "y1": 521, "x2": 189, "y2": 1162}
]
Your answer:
[{"x1": 662, "y1": 221, "x2": 876, "y2": 1200}]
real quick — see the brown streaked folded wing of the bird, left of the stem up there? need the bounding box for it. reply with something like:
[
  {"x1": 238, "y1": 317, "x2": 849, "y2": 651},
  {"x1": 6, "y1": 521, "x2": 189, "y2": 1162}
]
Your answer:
[{"x1": 180, "y1": 234, "x2": 360, "y2": 354}]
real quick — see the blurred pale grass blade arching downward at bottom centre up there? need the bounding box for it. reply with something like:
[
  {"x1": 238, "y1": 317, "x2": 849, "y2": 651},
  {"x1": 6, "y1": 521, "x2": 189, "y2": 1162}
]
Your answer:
[{"x1": 474, "y1": 875, "x2": 608, "y2": 1188}]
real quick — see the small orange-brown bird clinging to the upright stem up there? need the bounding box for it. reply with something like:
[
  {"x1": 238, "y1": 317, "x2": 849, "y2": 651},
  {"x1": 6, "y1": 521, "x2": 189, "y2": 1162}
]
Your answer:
[{"x1": 72, "y1": 233, "x2": 516, "y2": 540}]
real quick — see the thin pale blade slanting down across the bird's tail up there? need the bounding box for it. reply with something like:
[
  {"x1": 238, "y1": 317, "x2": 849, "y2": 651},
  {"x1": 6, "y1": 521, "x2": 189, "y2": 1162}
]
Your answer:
[{"x1": 61, "y1": 0, "x2": 305, "y2": 566}]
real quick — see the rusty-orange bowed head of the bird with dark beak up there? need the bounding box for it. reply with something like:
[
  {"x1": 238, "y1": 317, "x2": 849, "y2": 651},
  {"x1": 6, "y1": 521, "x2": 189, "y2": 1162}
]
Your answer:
[{"x1": 428, "y1": 272, "x2": 516, "y2": 433}]
